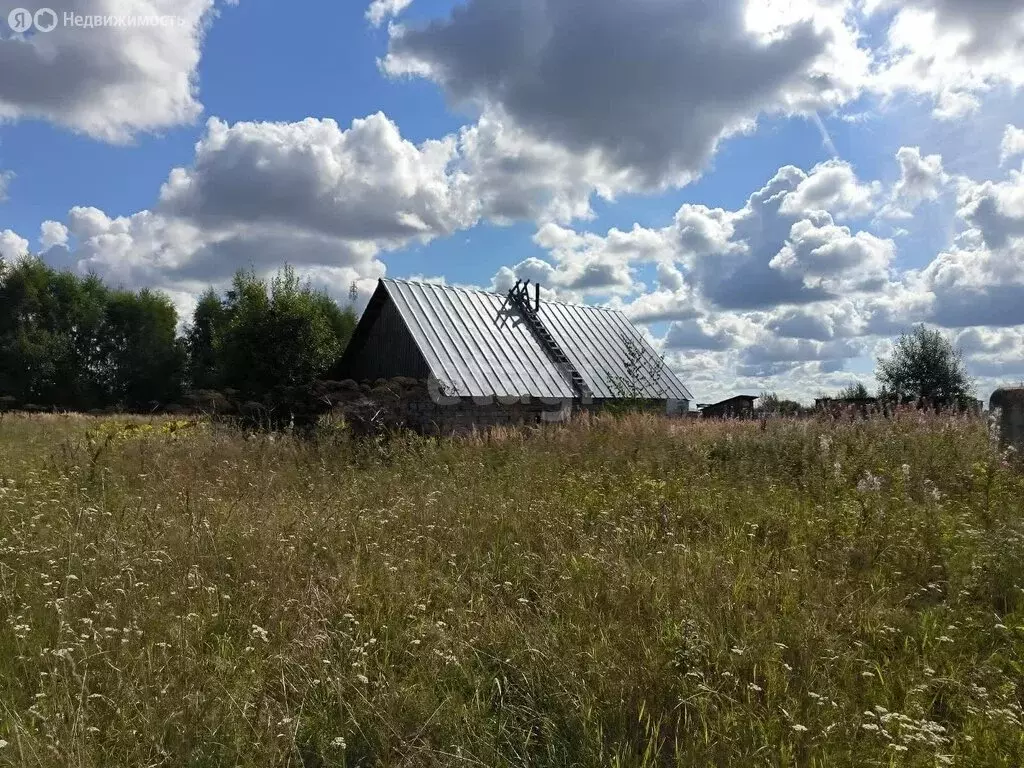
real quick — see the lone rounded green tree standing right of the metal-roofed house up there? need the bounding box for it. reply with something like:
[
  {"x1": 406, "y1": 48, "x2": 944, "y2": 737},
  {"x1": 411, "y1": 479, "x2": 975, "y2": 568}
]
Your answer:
[{"x1": 878, "y1": 325, "x2": 974, "y2": 407}]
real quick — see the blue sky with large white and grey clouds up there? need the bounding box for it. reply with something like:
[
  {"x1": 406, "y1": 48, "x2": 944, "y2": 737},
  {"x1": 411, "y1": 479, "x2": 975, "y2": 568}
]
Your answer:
[{"x1": 0, "y1": 0, "x2": 1024, "y2": 401}]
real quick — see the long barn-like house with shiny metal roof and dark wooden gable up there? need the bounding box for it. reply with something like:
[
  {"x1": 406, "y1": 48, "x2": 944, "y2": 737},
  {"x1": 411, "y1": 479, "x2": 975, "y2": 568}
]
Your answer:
[{"x1": 331, "y1": 279, "x2": 692, "y2": 428}]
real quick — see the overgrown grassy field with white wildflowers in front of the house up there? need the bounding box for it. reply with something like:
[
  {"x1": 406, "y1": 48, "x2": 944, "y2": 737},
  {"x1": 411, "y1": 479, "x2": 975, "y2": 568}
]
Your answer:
[{"x1": 0, "y1": 415, "x2": 1024, "y2": 768}]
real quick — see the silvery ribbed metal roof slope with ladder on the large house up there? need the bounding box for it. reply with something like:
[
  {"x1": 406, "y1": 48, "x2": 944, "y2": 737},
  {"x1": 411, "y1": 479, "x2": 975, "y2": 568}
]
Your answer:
[{"x1": 380, "y1": 279, "x2": 693, "y2": 400}]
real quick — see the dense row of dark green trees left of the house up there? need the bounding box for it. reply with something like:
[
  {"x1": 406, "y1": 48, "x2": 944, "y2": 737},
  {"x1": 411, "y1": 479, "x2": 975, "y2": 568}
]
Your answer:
[{"x1": 0, "y1": 257, "x2": 357, "y2": 411}]
